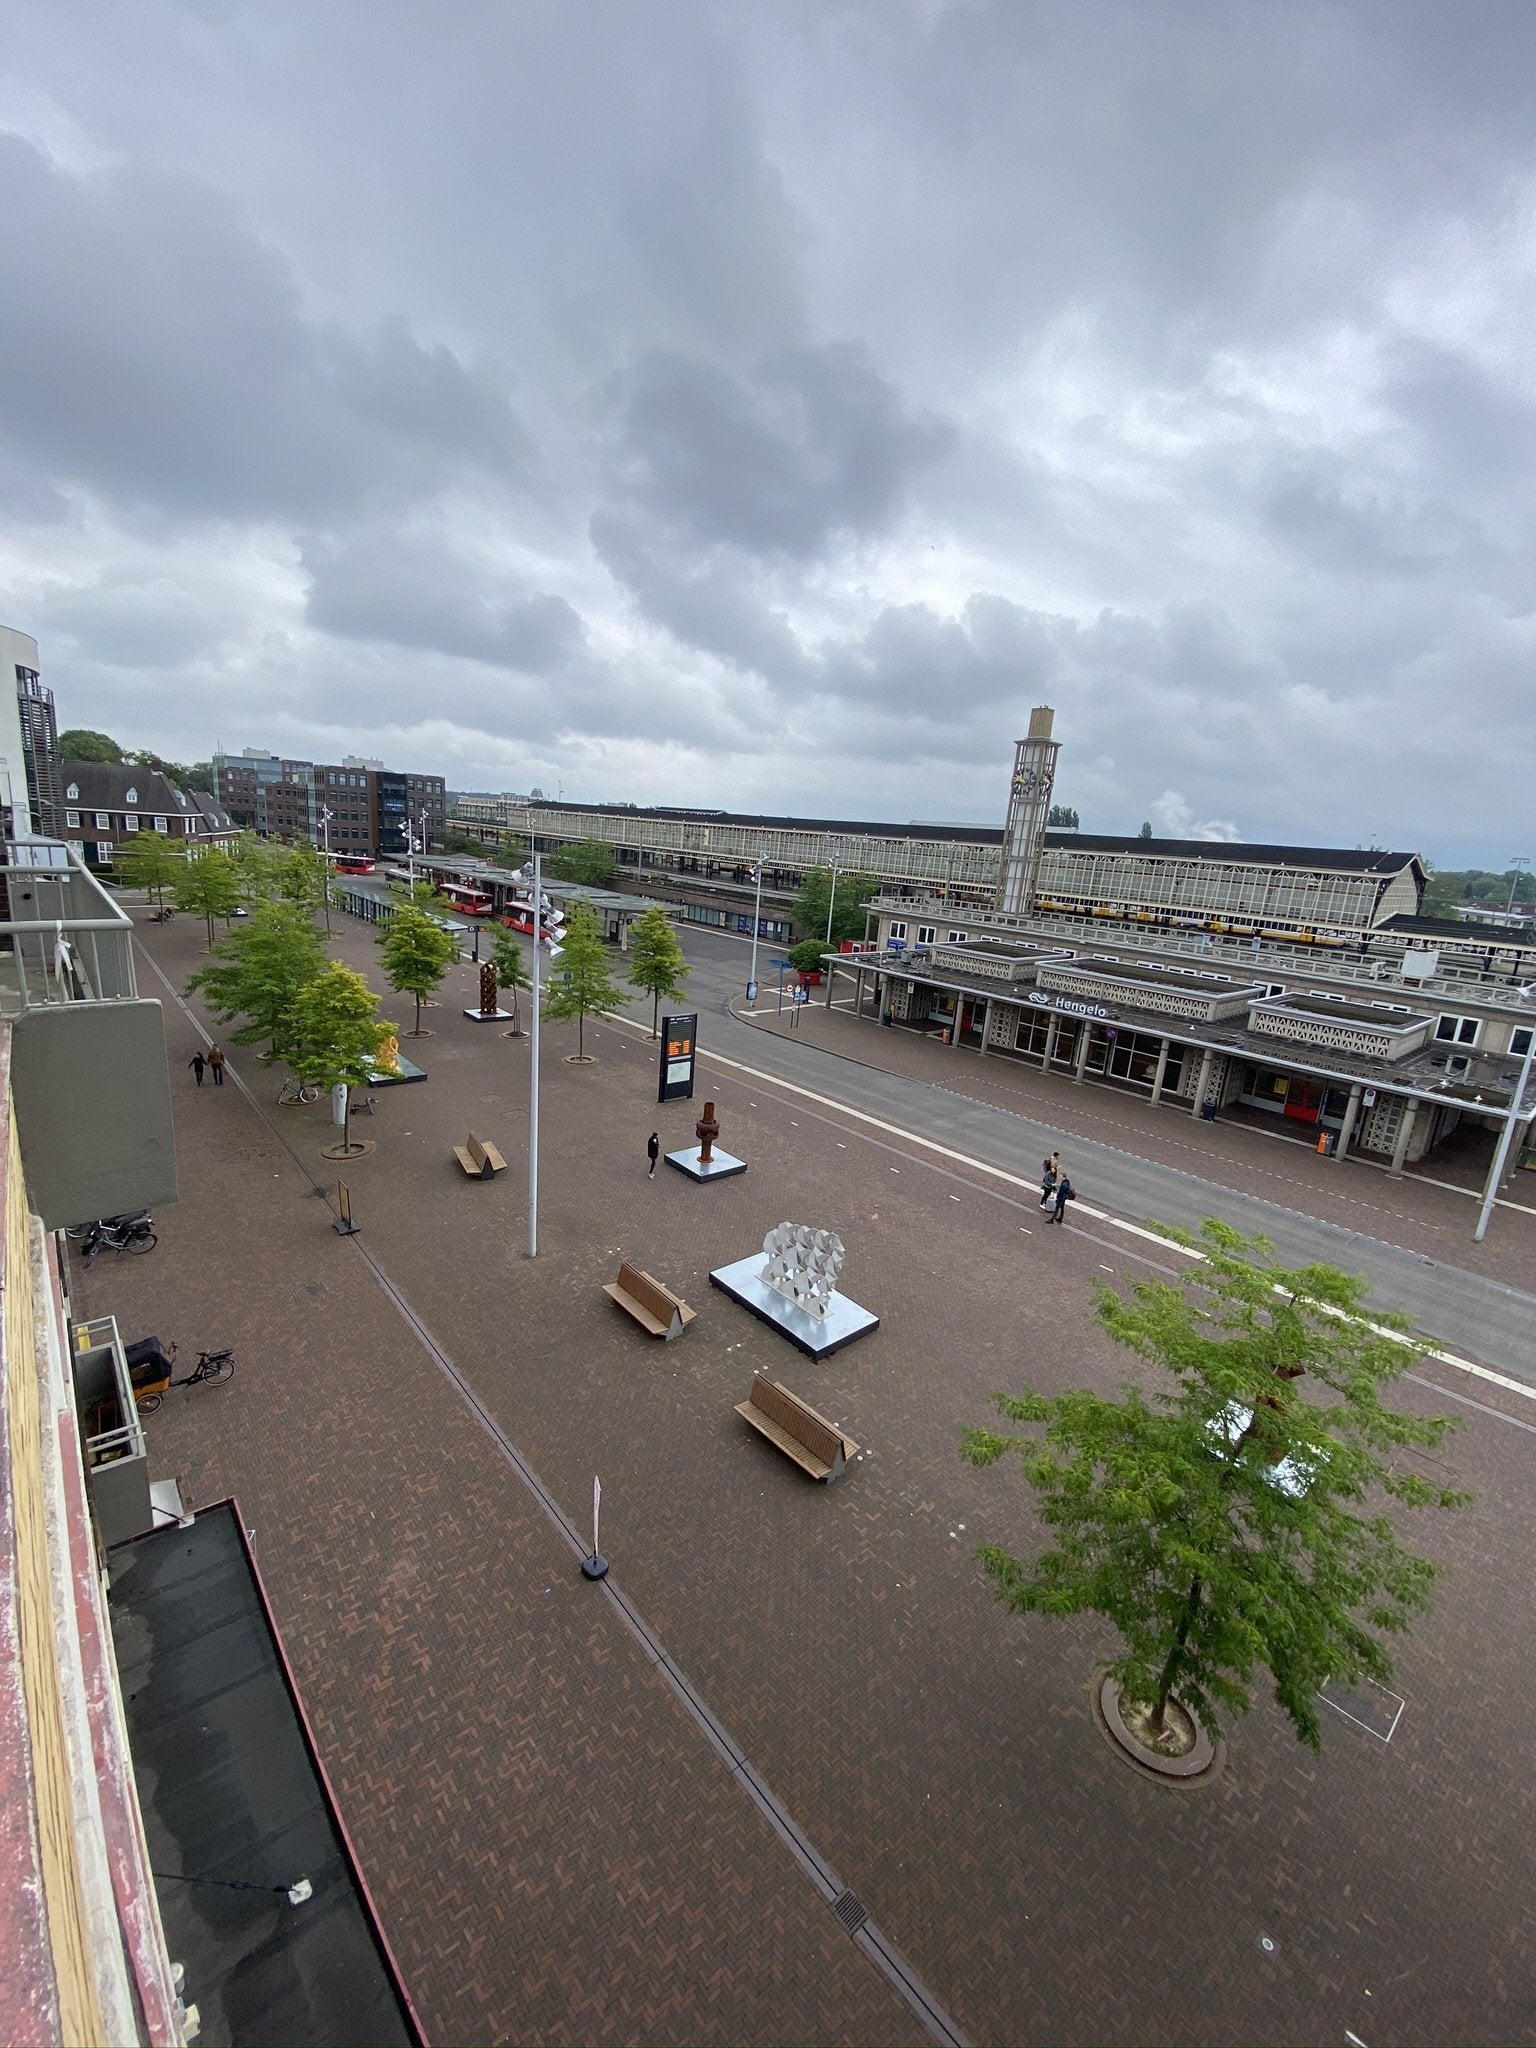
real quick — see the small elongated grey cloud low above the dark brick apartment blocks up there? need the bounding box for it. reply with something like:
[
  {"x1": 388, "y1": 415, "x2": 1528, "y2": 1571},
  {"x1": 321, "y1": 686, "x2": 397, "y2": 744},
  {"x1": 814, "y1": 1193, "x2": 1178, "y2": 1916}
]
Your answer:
[{"x1": 299, "y1": 530, "x2": 584, "y2": 674}]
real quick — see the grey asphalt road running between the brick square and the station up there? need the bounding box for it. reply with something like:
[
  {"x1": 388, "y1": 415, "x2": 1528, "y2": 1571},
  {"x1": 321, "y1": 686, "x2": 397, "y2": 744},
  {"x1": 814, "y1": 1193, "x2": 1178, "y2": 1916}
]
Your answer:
[{"x1": 633, "y1": 926, "x2": 1536, "y2": 1384}]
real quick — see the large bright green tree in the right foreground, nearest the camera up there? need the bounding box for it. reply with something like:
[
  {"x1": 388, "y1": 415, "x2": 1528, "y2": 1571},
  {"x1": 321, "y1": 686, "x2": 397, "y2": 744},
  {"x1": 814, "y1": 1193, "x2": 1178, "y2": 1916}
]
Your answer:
[{"x1": 963, "y1": 1219, "x2": 1466, "y2": 1749}]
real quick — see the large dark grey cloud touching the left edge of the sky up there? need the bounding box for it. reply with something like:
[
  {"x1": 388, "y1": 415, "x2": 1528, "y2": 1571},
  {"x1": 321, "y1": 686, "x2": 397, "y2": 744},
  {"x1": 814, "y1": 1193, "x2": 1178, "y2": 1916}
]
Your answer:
[{"x1": 0, "y1": 135, "x2": 526, "y2": 518}]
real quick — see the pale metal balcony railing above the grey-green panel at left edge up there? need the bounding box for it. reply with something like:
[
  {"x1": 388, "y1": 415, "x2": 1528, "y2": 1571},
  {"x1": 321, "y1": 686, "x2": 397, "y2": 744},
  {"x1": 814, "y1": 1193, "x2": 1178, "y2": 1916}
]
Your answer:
[{"x1": 0, "y1": 840, "x2": 139, "y2": 1018}]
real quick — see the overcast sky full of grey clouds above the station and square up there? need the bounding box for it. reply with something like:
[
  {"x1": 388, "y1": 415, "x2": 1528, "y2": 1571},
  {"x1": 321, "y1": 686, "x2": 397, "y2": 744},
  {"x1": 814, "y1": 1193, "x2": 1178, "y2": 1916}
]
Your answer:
[{"x1": 0, "y1": 0, "x2": 1536, "y2": 868}]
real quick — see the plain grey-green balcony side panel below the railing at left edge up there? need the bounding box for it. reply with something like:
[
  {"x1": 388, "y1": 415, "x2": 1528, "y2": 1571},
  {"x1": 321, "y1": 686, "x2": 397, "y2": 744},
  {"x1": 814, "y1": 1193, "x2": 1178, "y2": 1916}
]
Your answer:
[{"x1": 12, "y1": 1001, "x2": 176, "y2": 1231}]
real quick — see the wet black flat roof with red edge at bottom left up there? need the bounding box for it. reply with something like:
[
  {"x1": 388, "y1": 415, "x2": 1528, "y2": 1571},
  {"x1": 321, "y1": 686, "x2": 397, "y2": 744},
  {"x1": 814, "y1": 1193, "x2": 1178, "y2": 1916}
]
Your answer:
[{"x1": 106, "y1": 1501, "x2": 422, "y2": 2048}]
